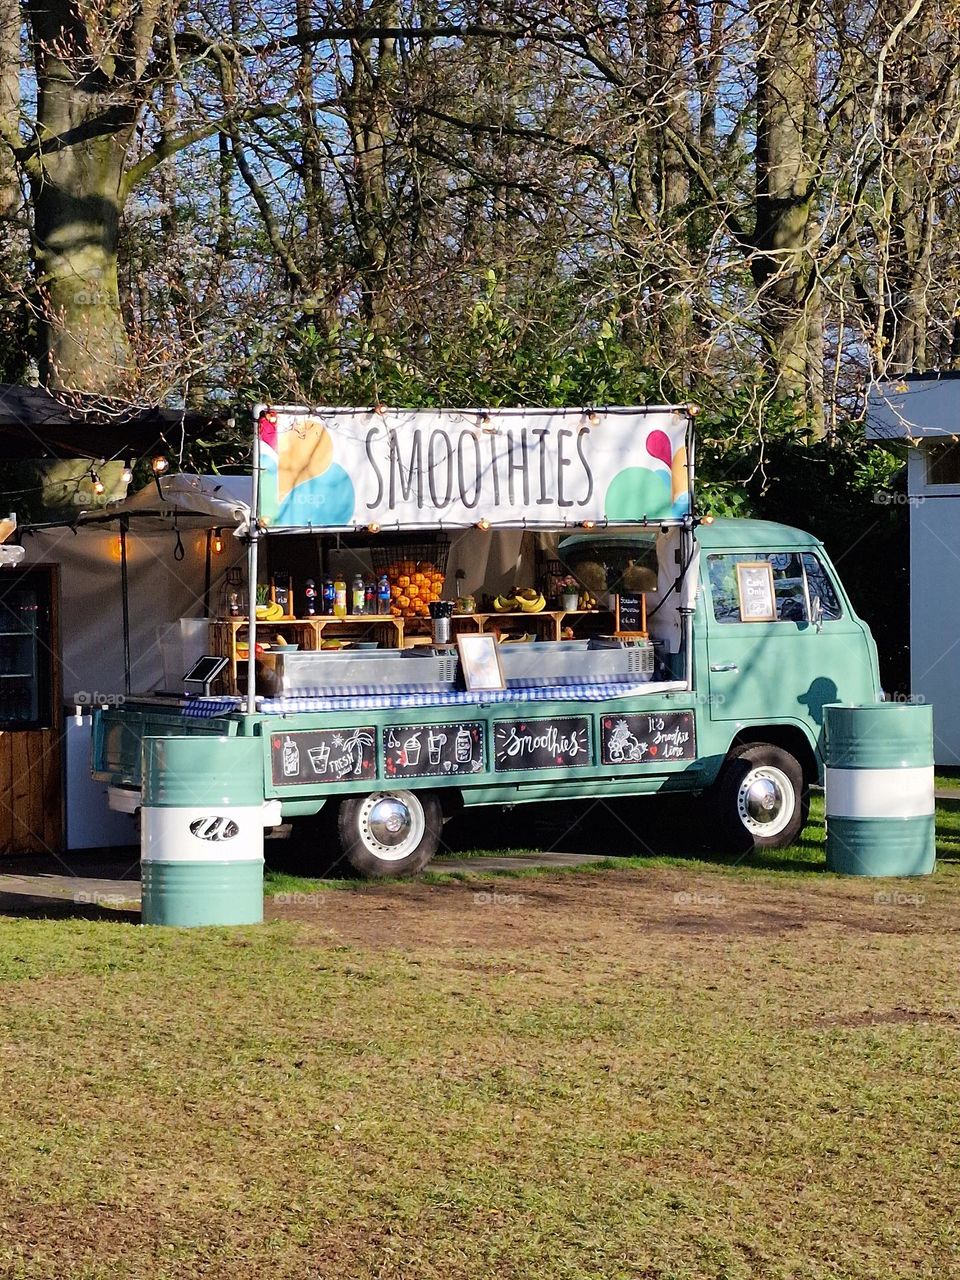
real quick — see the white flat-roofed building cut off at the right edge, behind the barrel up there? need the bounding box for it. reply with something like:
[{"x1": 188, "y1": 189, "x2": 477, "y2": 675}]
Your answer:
[{"x1": 867, "y1": 374, "x2": 960, "y2": 764}]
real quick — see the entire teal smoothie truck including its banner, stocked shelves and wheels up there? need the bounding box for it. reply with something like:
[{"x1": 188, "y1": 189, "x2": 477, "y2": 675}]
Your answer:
[{"x1": 93, "y1": 406, "x2": 882, "y2": 876}]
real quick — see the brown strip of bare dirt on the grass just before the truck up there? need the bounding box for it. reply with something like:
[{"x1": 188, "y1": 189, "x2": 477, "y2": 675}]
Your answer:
[{"x1": 268, "y1": 868, "x2": 956, "y2": 950}]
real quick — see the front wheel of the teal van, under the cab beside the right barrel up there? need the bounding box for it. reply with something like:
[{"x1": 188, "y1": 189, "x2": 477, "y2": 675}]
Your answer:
[{"x1": 710, "y1": 742, "x2": 810, "y2": 854}]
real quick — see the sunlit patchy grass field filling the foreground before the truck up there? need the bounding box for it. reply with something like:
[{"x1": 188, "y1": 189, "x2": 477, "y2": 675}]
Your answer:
[{"x1": 0, "y1": 804, "x2": 960, "y2": 1280}]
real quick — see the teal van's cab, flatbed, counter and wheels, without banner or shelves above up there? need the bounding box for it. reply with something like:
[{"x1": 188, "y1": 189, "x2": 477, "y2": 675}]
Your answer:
[{"x1": 93, "y1": 516, "x2": 882, "y2": 876}]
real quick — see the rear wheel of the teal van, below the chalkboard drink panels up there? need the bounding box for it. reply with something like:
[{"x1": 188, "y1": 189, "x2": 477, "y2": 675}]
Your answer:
[{"x1": 337, "y1": 791, "x2": 443, "y2": 878}]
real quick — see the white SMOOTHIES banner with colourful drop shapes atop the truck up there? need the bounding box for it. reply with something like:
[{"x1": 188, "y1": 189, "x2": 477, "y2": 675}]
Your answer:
[{"x1": 257, "y1": 407, "x2": 692, "y2": 531}]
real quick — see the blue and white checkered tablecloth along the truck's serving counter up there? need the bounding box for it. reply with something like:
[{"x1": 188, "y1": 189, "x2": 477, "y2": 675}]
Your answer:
[{"x1": 184, "y1": 681, "x2": 650, "y2": 719}]
